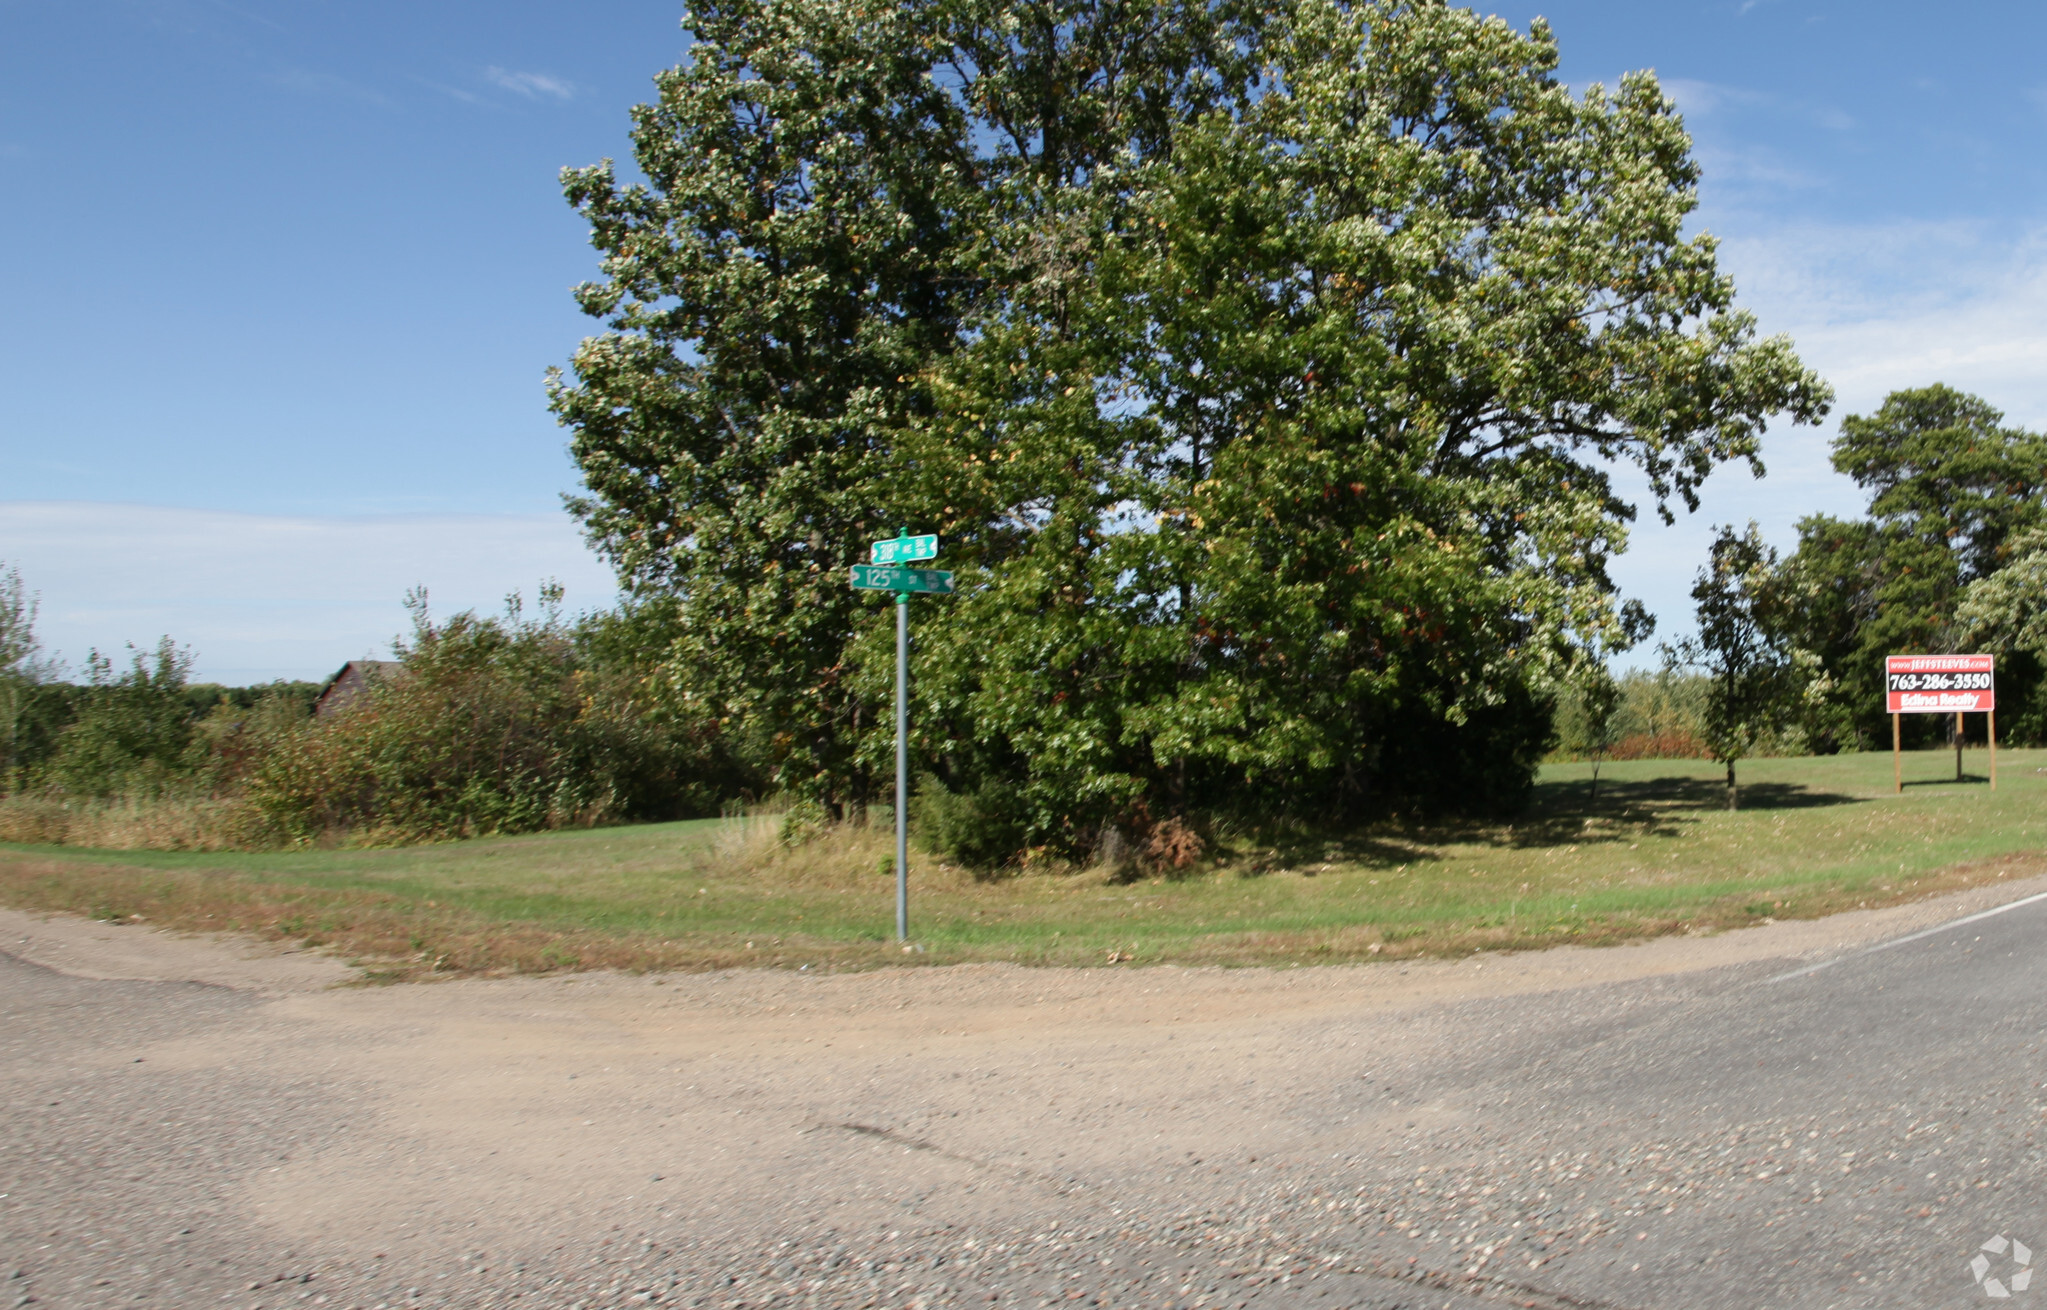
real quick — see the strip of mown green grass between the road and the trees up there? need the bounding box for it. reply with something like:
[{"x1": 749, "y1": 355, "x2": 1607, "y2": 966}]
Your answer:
[{"x1": 0, "y1": 751, "x2": 2047, "y2": 978}]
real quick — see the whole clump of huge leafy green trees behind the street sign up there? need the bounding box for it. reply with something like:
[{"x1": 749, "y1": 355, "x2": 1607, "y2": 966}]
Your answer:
[{"x1": 557, "y1": 2, "x2": 1828, "y2": 845}]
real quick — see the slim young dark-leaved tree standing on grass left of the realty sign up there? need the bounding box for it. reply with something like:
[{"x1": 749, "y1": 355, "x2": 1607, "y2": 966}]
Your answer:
[{"x1": 1664, "y1": 520, "x2": 1799, "y2": 811}]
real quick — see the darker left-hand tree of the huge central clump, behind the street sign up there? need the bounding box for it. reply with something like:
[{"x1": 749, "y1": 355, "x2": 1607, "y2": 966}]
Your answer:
[{"x1": 553, "y1": 0, "x2": 1243, "y2": 806}]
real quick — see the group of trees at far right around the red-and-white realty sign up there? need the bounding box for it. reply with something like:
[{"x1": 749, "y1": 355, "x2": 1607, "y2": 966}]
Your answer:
[{"x1": 1562, "y1": 383, "x2": 2047, "y2": 806}]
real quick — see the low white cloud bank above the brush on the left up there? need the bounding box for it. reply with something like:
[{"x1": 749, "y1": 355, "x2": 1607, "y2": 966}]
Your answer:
[{"x1": 0, "y1": 501, "x2": 616, "y2": 684}]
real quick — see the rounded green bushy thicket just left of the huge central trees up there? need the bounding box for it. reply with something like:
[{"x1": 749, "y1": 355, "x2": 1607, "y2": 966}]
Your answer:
[{"x1": 246, "y1": 590, "x2": 723, "y2": 843}]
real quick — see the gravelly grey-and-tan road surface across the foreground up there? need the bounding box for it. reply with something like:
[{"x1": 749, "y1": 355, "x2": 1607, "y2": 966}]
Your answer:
[{"x1": 0, "y1": 880, "x2": 2047, "y2": 1310}]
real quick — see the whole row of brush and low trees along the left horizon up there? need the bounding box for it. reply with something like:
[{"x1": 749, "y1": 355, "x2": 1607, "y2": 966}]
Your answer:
[{"x1": 0, "y1": 569, "x2": 747, "y2": 845}]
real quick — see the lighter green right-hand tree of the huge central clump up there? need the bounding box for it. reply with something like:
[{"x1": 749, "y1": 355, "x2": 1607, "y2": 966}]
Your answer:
[{"x1": 904, "y1": 6, "x2": 1826, "y2": 831}]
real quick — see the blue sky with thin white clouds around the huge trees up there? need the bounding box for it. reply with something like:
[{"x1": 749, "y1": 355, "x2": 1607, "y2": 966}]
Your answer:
[{"x1": 0, "y1": 0, "x2": 2047, "y2": 682}]
